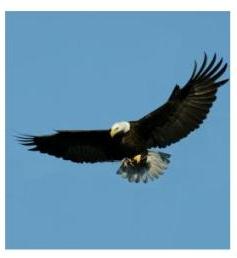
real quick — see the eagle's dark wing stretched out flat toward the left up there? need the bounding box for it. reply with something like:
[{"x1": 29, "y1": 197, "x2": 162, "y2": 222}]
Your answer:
[{"x1": 18, "y1": 130, "x2": 129, "y2": 163}]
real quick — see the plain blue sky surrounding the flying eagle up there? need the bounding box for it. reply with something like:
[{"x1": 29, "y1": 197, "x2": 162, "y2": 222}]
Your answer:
[{"x1": 6, "y1": 12, "x2": 229, "y2": 249}]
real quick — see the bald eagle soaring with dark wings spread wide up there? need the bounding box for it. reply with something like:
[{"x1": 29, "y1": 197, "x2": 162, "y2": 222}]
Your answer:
[{"x1": 18, "y1": 54, "x2": 228, "y2": 183}]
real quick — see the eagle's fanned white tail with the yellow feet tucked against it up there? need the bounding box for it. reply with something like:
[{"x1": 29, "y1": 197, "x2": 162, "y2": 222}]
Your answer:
[{"x1": 117, "y1": 151, "x2": 170, "y2": 183}]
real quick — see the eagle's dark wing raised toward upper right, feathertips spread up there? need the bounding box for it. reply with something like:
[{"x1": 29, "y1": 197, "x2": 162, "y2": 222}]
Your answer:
[{"x1": 136, "y1": 54, "x2": 228, "y2": 147}]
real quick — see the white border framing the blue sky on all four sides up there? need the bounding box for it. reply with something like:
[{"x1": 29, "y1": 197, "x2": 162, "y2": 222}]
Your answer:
[{"x1": 0, "y1": 0, "x2": 237, "y2": 258}]
